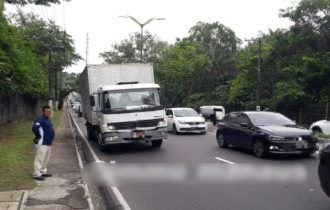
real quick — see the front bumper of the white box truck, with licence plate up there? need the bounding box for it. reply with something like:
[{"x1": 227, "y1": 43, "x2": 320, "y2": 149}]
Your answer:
[{"x1": 102, "y1": 127, "x2": 167, "y2": 145}]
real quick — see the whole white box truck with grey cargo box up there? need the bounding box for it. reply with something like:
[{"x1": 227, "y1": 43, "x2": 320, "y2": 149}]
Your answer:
[{"x1": 80, "y1": 63, "x2": 167, "y2": 149}]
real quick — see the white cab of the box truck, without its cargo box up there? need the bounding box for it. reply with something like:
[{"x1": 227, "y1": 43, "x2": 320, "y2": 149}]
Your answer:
[{"x1": 91, "y1": 82, "x2": 167, "y2": 147}]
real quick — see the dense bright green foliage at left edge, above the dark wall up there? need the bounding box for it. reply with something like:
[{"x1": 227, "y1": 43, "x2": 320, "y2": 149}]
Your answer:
[{"x1": 0, "y1": 19, "x2": 46, "y2": 96}]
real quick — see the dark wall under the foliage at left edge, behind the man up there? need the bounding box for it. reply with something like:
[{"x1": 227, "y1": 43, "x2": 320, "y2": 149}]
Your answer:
[{"x1": 0, "y1": 94, "x2": 47, "y2": 124}]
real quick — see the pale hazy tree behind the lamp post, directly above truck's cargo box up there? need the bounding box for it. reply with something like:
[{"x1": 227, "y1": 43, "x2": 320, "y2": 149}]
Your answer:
[{"x1": 100, "y1": 32, "x2": 168, "y2": 63}]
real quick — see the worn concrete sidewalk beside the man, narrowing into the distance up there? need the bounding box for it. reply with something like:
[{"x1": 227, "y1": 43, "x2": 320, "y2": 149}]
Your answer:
[{"x1": 0, "y1": 106, "x2": 89, "y2": 210}]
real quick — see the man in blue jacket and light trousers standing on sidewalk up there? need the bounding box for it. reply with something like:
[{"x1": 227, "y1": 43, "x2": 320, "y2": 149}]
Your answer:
[{"x1": 32, "y1": 106, "x2": 55, "y2": 181}]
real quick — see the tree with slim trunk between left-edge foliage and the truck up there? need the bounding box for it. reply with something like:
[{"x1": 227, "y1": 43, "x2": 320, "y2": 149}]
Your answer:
[{"x1": 12, "y1": 12, "x2": 81, "y2": 99}]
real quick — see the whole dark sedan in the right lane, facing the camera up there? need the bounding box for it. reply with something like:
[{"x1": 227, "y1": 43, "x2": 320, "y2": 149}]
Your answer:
[{"x1": 216, "y1": 111, "x2": 317, "y2": 158}]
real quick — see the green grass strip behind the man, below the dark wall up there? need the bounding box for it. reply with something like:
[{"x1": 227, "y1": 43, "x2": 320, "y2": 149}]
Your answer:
[{"x1": 0, "y1": 111, "x2": 62, "y2": 191}]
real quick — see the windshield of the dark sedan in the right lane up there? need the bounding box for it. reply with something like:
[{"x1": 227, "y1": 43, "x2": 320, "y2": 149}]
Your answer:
[{"x1": 248, "y1": 112, "x2": 295, "y2": 126}]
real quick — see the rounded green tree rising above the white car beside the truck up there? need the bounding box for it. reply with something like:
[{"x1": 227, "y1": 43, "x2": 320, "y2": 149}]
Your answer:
[{"x1": 155, "y1": 41, "x2": 211, "y2": 106}]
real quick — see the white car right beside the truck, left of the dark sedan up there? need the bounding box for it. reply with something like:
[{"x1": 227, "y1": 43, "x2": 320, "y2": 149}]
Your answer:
[{"x1": 166, "y1": 108, "x2": 206, "y2": 134}]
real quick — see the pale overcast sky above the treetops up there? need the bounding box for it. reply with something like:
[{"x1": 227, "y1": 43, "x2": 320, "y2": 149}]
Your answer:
[{"x1": 5, "y1": 0, "x2": 298, "y2": 73}]
